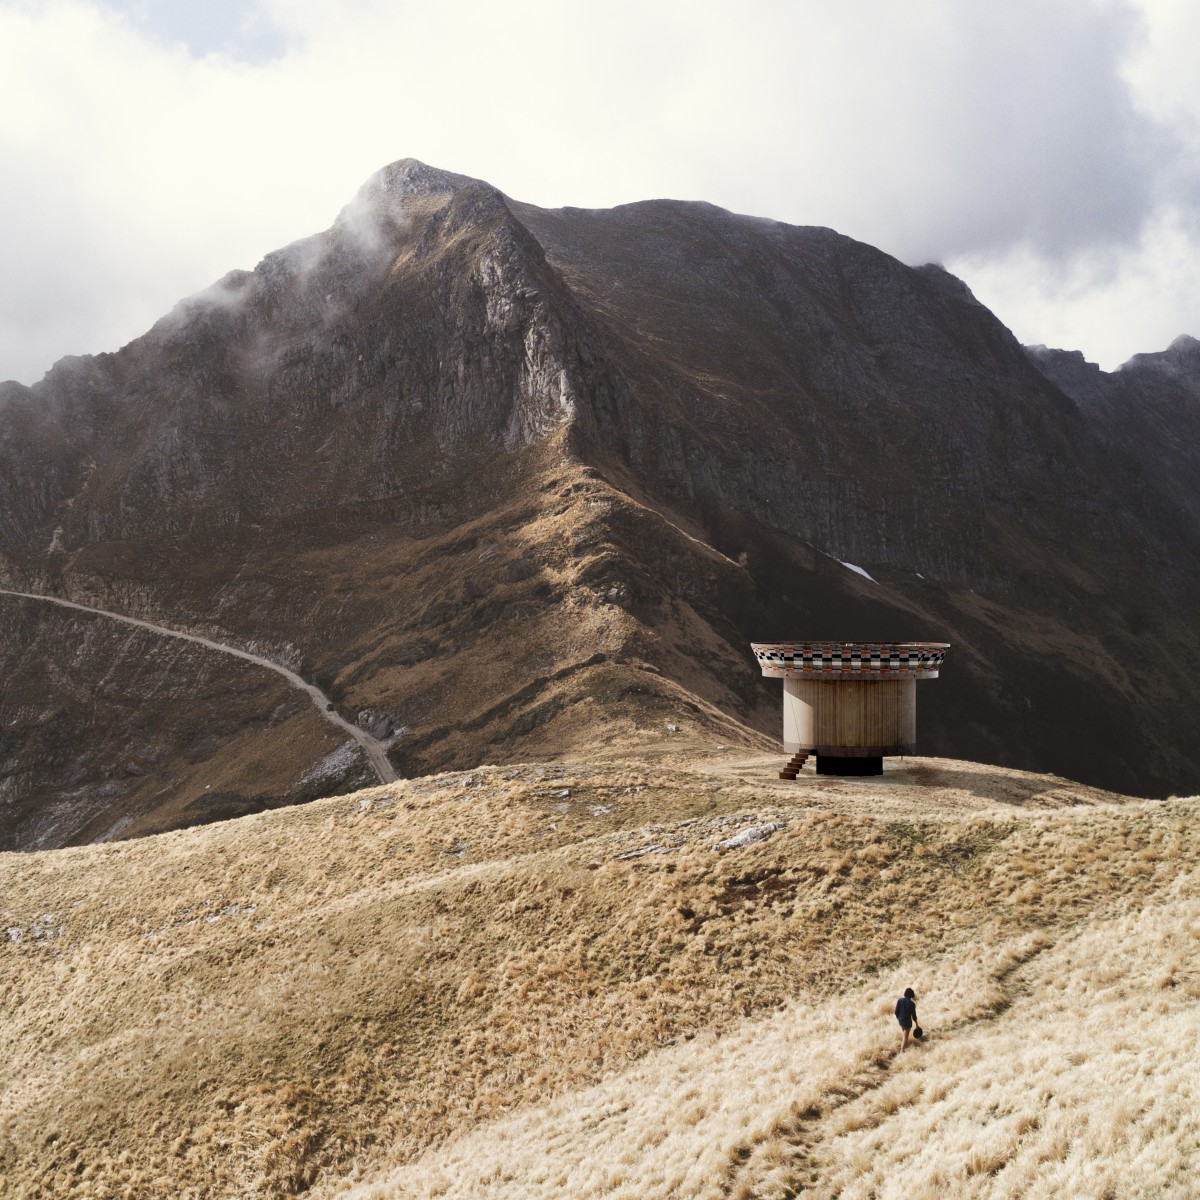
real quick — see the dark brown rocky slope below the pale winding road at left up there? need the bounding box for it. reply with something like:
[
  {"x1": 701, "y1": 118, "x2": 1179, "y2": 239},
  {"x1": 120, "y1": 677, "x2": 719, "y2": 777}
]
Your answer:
[{"x1": 0, "y1": 598, "x2": 360, "y2": 850}]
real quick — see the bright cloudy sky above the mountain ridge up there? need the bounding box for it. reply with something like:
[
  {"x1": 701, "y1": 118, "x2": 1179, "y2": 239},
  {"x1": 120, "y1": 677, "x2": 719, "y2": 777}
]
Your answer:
[{"x1": 0, "y1": 0, "x2": 1200, "y2": 383}]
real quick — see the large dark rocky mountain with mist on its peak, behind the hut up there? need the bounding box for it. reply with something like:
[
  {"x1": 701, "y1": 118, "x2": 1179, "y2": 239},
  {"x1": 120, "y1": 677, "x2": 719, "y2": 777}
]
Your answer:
[{"x1": 0, "y1": 160, "x2": 1200, "y2": 848}]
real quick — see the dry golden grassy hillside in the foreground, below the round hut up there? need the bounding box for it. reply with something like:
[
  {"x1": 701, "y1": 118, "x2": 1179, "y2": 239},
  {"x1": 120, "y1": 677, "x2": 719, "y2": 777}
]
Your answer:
[{"x1": 0, "y1": 740, "x2": 1200, "y2": 1198}]
